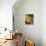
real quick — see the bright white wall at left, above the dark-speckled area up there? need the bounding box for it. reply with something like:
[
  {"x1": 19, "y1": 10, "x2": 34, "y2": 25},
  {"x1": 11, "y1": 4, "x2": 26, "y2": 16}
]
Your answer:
[{"x1": 0, "y1": 0, "x2": 16, "y2": 29}]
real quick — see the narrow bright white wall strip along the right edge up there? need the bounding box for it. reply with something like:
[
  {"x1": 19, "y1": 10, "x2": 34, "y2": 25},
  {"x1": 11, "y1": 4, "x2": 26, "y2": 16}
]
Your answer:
[{"x1": 41, "y1": 0, "x2": 46, "y2": 46}]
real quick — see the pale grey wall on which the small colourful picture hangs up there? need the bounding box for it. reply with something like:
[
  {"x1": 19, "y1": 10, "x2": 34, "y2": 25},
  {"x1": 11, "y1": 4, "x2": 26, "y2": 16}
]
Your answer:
[{"x1": 13, "y1": 0, "x2": 41, "y2": 46}]
